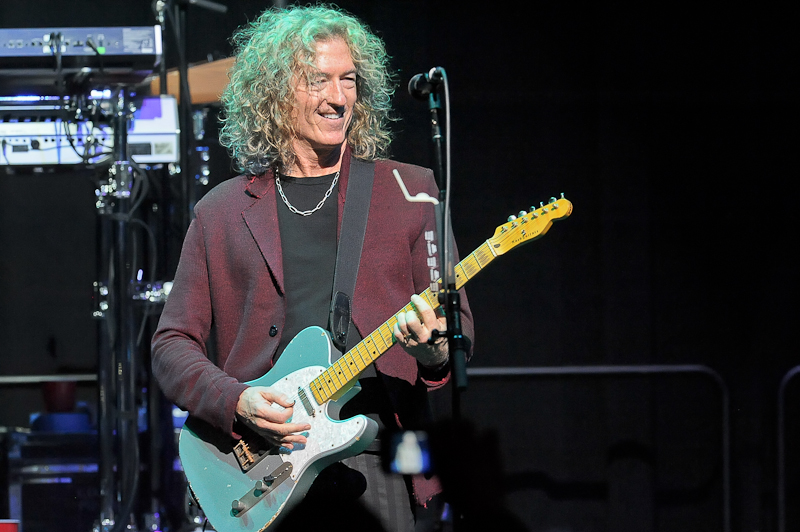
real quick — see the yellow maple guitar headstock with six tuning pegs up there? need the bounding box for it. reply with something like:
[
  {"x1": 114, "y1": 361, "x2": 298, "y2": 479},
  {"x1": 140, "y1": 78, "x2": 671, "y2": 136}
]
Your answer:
[{"x1": 487, "y1": 194, "x2": 572, "y2": 255}]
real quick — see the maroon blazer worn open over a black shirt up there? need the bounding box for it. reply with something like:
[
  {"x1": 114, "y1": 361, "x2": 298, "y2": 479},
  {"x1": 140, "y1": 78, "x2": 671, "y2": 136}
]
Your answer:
[{"x1": 152, "y1": 150, "x2": 474, "y2": 503}]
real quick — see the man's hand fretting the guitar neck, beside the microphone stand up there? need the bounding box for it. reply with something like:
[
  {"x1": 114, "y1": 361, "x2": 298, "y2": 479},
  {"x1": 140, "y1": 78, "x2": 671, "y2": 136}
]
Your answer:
[{"x1": 392, "y1": 294, "x2": 448, "y2": 368}]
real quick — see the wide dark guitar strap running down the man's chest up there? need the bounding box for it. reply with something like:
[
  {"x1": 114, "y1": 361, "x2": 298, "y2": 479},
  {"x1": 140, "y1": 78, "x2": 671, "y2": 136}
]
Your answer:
[{"x1": 329, "y1": 157, "x2": 375, "y2": 358}]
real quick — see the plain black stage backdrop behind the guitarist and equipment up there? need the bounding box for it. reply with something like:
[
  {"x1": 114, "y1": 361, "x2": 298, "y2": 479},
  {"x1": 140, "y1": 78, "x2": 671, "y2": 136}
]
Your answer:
[{"x1": 0, "y1": 0, "x2": 800, "y2": 532}]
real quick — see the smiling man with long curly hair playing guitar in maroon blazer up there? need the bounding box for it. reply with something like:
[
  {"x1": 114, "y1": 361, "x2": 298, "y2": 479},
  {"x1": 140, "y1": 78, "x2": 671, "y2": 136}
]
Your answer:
[{"x1": 153, "y1": 6, "x2": 472, "y2": 531}]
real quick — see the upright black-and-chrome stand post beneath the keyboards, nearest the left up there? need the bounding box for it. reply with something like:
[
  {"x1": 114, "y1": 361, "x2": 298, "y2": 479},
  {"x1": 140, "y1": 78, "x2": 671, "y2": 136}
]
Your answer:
[{"x1": 95, "y1": 88, "x2": 139, "y2": 532}]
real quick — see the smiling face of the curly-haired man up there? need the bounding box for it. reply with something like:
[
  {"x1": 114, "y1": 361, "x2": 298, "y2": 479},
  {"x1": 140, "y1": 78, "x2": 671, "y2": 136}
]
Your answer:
[{"x1": 292, "y1": 38, "x2": 356, "y2": 164}]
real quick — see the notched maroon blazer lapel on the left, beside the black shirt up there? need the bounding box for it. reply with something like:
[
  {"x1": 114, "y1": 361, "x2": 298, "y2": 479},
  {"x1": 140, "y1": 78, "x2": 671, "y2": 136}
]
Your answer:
[{"x1": 242, "y1": 172, "x2": 284, "y2": 294}]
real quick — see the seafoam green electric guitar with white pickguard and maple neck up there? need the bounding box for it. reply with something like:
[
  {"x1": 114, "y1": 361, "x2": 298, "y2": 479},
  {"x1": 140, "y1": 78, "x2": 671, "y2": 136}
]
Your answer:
[{"x1": 179, "y1": 194, "x2": 572, "y2": 532}]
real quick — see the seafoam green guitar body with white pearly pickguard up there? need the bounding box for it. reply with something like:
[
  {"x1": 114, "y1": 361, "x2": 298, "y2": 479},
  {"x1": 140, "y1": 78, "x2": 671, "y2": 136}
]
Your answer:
[{"x1": 179, "y1": 327, "x2": 378, "y2": 532}]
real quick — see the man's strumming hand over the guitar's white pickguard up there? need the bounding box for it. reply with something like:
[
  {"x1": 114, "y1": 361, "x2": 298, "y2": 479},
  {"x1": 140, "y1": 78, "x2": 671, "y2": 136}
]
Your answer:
[{"x1": 236, "y1": 386, "x2": 311, "y2": 449}]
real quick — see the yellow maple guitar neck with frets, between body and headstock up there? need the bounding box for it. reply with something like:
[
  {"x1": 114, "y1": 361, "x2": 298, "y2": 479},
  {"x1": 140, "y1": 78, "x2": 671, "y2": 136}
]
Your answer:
[{"x1": 311, "y1": 240, "x2": 496, "y2": 404}]
